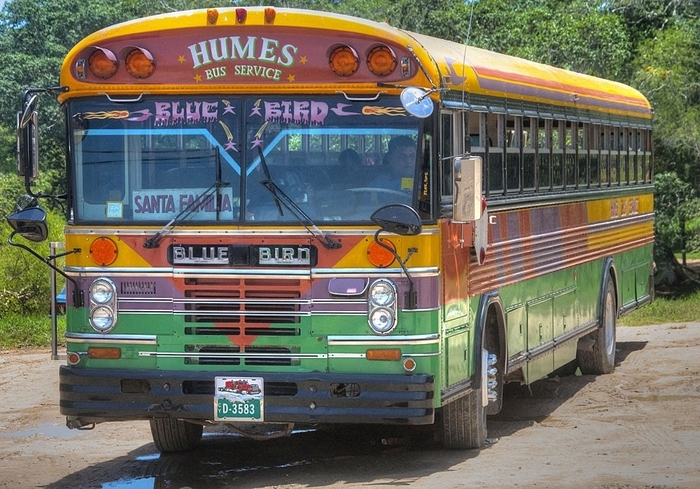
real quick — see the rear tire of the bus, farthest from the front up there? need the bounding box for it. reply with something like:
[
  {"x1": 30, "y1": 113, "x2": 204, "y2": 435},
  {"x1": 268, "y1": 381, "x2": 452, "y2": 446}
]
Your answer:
[{"x1": 576, "y1": 275, "x2": 617, "y2": 375}]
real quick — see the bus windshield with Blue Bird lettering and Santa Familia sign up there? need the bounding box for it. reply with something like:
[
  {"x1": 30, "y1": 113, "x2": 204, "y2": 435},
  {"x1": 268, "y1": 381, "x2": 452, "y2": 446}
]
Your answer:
[{"x1": 68, "y1": 96, "x2": 430, "y2": 224}]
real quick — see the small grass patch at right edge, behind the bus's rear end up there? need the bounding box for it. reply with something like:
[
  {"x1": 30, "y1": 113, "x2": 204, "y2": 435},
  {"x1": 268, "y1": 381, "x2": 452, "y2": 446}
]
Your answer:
[{"x1": 618, "y1": 291, "x2": 700, "y2": 326}]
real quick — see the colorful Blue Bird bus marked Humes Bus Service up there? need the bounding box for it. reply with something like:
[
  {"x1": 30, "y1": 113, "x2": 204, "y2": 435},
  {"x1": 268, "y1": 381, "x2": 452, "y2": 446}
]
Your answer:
[{"x1": 10, "y1": 7, "x2": 654, "y2": 451}]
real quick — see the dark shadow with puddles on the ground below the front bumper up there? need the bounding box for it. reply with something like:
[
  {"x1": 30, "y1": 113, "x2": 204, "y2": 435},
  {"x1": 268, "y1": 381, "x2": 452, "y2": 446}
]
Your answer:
[{"x1": 49, "y1": 427, "x2": 448, "y2": 489}]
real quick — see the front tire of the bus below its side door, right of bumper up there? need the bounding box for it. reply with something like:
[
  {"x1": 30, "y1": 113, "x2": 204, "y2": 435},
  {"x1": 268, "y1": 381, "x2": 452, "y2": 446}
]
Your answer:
[{"x1": 441, "y1": 348, "x2": 486, "y2": 450}]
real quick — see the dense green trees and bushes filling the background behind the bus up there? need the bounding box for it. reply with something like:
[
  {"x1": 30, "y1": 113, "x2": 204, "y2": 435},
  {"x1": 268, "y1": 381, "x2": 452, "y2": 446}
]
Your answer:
[{"x1": 0, "y1": 0, "x2": 700, "y2": 316}]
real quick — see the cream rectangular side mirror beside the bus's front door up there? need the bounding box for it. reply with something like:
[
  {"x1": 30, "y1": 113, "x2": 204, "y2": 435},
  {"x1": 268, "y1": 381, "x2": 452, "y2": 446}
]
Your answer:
[{"x1": 452, "y1": 156, "x2": 483, "y2": 222}]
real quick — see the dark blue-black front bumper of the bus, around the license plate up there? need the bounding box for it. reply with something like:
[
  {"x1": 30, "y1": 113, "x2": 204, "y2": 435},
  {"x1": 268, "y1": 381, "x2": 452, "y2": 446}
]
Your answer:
[{"x1": 59, "y1": 366, "x2": 435, "y2": 426}]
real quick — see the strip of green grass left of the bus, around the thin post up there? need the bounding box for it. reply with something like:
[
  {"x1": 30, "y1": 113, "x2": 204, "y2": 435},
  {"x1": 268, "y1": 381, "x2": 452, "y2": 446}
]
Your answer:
[{"x1": 0, "y1": 314, "x2": 66, "y2": 350}]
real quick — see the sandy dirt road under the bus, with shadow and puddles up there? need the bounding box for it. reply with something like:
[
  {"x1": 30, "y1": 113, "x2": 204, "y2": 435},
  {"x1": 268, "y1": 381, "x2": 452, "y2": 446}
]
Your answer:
[{"x1": 0, "y1": 323, "x2": 700, "y2": 489}]
